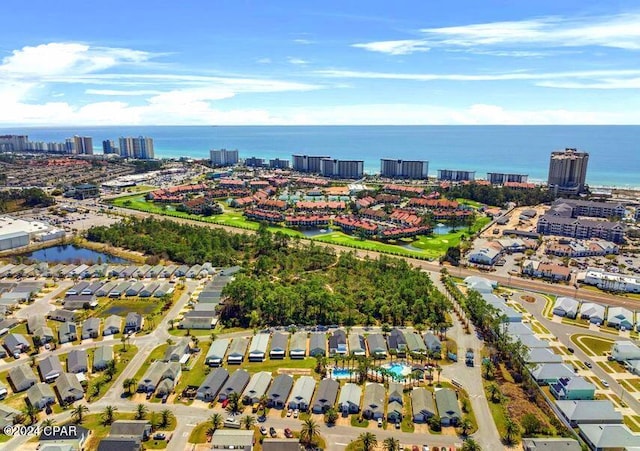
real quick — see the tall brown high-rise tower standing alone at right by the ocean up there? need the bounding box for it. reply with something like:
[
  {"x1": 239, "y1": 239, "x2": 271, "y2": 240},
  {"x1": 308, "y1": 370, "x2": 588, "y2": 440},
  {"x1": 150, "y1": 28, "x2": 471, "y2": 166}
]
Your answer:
[{"x1": 547, "y1": 148, "x2": 589, "y2": 194}]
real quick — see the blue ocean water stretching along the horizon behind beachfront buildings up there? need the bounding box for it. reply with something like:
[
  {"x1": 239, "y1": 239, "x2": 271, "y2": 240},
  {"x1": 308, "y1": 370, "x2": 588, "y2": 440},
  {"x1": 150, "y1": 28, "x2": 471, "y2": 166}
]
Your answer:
[{"x1": 0, "y1": 126, "x2": 640, "y2": 187}]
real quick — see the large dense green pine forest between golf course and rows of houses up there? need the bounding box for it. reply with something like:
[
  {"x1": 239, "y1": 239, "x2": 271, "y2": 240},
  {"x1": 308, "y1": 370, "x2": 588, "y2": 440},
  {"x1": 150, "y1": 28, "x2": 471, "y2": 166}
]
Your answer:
[{"x1": 88, "y1": 219, "x2": 450, "y2": 327}]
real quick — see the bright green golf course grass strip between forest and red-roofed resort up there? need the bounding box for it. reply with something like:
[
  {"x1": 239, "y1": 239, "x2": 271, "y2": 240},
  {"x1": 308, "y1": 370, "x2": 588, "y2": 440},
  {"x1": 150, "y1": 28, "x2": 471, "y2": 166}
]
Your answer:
[{"x1": 112, "y1": 195, "x2": 491, "y2": 259}]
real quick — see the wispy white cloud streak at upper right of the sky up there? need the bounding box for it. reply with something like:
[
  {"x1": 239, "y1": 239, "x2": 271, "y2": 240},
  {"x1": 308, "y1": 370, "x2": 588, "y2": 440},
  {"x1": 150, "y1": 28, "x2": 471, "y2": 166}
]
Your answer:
[{"x1": 353, "y1": 13, "x2": 640, "y2": 57}]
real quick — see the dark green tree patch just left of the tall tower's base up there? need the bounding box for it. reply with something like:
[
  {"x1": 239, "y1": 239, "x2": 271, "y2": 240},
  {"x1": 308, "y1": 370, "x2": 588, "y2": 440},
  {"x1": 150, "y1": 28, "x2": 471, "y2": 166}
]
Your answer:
[{"x1": 444, "y1": 183, "x2": 554, "y2": 207}]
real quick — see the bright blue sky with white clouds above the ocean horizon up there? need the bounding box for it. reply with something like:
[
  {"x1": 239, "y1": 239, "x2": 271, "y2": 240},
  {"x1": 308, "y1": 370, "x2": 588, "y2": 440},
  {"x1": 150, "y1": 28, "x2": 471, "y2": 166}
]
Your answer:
[{"x1": 0, "y1": 0, "x2": 640, "y2": 126}]
